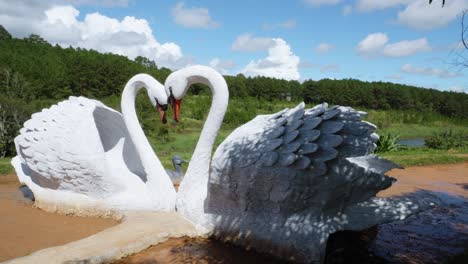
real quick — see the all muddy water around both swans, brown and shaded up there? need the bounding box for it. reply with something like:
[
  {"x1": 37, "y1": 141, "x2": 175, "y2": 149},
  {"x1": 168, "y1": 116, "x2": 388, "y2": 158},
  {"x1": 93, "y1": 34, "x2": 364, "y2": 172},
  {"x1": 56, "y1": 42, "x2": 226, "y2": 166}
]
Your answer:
[{"x1": 0, "y1": 163, "x2": 468, "y2": 264}]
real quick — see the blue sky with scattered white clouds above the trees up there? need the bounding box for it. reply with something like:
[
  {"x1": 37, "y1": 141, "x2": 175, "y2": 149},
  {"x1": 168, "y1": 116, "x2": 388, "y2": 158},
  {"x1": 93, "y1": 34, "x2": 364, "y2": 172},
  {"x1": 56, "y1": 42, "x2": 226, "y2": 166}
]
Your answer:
[{"x1": 0, "y1": 0, "x2": 468, "y2": 92}]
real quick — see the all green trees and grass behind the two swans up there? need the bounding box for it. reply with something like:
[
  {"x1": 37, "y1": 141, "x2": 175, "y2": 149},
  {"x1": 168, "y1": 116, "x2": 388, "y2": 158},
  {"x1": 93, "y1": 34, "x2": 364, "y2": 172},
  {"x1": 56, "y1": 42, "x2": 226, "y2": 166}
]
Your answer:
[{"x1": 0, "y1": 27, "x2": 468, "y2": 169}]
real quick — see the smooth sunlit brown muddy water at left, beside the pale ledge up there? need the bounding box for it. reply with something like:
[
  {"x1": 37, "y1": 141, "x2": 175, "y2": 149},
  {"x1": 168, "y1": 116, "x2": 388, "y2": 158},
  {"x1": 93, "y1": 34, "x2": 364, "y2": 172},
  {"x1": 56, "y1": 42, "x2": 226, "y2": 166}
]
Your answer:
[{"x1": 0, "y1": 175, "x2": 118, "y2": 262}]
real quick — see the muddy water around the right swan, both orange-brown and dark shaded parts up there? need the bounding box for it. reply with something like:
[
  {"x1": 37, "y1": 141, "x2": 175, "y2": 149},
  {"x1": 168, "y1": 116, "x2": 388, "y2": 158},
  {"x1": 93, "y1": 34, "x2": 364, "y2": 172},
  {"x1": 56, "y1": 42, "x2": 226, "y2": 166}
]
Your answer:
[{"x1": 116, "y1": 163, "x2": 468, "y2": 264}]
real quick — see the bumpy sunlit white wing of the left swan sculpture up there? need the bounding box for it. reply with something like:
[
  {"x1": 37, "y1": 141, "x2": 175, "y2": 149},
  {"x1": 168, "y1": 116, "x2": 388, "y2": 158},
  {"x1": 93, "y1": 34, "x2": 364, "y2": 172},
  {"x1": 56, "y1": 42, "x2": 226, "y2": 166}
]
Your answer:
[{"x1": 15, "y1": 97, "x2": 132, "y2": 197}]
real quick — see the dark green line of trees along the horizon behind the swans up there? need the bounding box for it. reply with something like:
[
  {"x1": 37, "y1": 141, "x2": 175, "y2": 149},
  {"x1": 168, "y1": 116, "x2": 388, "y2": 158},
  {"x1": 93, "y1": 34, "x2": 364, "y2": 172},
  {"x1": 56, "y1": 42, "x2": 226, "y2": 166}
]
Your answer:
[{"x1": 0, "y1": 26, "x2": 468, "y2": 156}]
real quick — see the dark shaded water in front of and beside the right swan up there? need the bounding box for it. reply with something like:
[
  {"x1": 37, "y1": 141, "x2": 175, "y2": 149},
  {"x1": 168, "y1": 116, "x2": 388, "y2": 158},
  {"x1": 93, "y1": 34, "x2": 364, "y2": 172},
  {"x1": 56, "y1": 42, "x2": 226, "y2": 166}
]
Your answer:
[{"x1": 117, "y1": 191, "x2": 468, "y2": 264}]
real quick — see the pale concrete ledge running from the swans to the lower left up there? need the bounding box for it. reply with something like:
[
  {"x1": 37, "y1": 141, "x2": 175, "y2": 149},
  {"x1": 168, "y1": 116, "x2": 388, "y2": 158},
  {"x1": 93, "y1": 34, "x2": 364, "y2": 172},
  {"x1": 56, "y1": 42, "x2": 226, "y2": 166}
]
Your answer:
[{"x1": 4, "y1": 212, "x2": 199, "y2": 264}]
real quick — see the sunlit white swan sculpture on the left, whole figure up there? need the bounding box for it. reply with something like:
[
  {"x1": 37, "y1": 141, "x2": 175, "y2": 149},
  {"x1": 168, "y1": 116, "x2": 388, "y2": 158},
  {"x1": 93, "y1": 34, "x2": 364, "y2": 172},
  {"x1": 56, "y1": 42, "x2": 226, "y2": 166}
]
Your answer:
[{"x1": 12, "y1": 74, "x2": 176, "y2": 215}]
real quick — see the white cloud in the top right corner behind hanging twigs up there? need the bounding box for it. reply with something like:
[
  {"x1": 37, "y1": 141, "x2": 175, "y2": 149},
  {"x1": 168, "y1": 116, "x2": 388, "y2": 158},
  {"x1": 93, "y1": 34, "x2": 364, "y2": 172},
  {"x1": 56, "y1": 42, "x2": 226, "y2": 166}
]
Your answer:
[{"x1": 396, "y1": 0, "x2": 468, "y2": 30}]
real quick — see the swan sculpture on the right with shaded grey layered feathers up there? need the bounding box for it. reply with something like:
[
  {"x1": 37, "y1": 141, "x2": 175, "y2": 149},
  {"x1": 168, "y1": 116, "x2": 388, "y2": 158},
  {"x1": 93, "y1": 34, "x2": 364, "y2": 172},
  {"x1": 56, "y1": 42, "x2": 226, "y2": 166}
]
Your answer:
[{"x1": 165, "y1": 66, "x2": 436, "y2": 263}]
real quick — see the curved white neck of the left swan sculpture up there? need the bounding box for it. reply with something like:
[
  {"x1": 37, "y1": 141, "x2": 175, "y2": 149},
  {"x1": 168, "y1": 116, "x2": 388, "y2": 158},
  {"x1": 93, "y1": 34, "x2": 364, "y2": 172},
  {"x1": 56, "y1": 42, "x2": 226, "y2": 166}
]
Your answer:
[{"x1": 121, "y1": 75, "x2": 166, "y2": 181}]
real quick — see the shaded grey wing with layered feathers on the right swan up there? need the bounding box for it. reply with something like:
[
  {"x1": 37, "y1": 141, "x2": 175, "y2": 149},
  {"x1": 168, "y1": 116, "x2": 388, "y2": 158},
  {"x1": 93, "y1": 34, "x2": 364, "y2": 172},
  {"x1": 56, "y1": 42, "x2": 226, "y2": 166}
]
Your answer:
[{"x1": 210, "y1": 103, "x2": 398, "y2": 216}]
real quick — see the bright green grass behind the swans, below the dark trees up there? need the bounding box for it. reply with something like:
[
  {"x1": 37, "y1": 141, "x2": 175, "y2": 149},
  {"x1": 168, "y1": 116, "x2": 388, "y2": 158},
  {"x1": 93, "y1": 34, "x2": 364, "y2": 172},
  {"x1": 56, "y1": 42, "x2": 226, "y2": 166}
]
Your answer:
[{"x1": 0, "y1": 97, "x2": 468, "y2": 174}]
